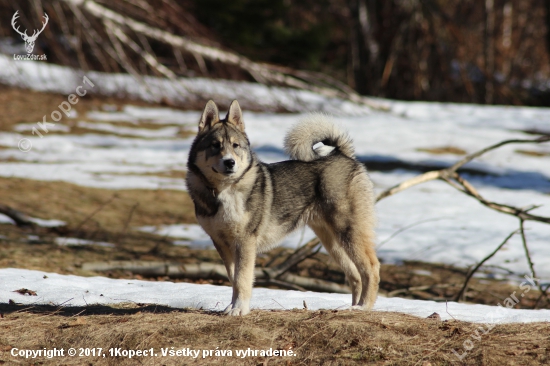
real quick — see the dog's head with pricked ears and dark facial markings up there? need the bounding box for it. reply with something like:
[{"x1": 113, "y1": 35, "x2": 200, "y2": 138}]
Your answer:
[{"x1": 189, "y1": 100, "x2": 251, "y2": 183}]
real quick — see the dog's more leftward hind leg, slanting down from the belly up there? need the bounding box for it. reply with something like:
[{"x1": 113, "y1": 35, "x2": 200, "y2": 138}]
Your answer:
[{"x1": 310, "y1": 224, "x2": 362, "y2": 305}]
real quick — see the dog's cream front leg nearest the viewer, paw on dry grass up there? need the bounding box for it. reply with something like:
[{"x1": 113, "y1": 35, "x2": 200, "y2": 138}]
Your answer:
[{"x1": 225, "y1": 239, "x2": 256, "y2": 315}]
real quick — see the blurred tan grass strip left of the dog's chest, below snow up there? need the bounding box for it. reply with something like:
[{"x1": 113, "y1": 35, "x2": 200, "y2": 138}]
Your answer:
[{"x1": 0, "y1": 176, "x2": 196, "y2": 231}]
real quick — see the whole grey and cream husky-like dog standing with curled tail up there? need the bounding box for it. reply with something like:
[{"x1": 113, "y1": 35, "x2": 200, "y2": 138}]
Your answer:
[{"x1": 187, "y1": 101, "x2": 380, "y2": 315}]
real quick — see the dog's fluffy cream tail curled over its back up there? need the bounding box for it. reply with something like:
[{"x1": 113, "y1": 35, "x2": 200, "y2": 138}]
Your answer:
[{"x1": 285, "y1": 113, "x2": 355, "y2": 161}]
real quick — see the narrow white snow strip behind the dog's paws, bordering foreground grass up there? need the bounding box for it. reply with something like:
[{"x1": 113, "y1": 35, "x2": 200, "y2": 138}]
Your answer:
[{"x1": 0, "y1": 268, "x2": 550, "y2": 324}]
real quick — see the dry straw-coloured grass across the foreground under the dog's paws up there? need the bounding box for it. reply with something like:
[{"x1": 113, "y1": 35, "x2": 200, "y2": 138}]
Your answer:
[{"x1": 0, "y1": 305, "x2": 550, "y2": 366}]
